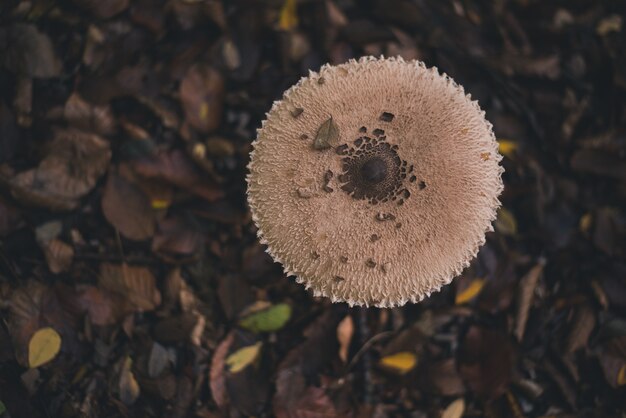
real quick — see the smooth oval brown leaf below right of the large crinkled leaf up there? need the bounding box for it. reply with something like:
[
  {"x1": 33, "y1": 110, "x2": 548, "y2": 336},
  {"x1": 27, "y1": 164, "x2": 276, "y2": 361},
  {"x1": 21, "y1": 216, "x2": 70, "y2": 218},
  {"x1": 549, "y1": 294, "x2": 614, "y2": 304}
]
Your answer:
[{"x1": 102, "y1": 170, "x2": 155, "y2": 241}]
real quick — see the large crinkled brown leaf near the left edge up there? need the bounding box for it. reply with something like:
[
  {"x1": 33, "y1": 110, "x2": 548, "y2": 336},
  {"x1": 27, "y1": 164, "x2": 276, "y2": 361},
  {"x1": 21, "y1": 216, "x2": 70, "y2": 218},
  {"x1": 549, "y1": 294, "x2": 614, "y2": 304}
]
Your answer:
[{"x1": 8, "y1": 130, "x2": 111, "y2": 210}]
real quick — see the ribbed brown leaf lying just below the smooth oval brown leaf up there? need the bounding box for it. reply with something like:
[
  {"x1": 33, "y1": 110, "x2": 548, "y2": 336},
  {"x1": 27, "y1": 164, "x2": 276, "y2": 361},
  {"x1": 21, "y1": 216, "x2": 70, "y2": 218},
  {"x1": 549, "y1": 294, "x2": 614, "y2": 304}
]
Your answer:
[{"x1": 98, "y1": 263, "x2": 161, "y2": 311}]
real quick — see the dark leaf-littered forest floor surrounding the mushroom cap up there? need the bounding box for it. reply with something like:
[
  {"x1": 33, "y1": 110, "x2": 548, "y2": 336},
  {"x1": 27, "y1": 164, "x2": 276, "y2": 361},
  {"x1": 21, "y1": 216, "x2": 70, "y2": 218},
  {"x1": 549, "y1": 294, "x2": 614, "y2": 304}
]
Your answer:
[{"x1": 0, "y1": 0, "x2": 626, "y2": 418}]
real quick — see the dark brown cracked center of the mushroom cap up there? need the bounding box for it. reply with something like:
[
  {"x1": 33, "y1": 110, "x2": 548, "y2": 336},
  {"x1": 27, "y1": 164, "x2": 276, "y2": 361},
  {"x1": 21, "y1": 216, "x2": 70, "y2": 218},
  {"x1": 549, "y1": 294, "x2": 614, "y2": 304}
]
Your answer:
[{"x1": 336, "y1": 128, "x2": 413, "y2": 205}]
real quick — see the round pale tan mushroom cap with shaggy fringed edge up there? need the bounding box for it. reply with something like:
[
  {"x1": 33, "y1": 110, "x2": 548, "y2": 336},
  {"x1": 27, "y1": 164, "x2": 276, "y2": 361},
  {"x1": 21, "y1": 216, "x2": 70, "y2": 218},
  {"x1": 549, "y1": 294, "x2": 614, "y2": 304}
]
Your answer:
[{"x1": 247, "y1": 57, "x2": 503, "y2": 307}]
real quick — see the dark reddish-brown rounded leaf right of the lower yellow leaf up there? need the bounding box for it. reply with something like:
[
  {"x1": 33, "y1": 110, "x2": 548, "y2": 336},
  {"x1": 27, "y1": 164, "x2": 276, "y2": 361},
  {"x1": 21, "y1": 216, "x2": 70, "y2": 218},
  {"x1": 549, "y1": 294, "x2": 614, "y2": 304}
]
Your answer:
[{"x1": 458, "y1": 325, "x2": 513, "y2": 399}]
